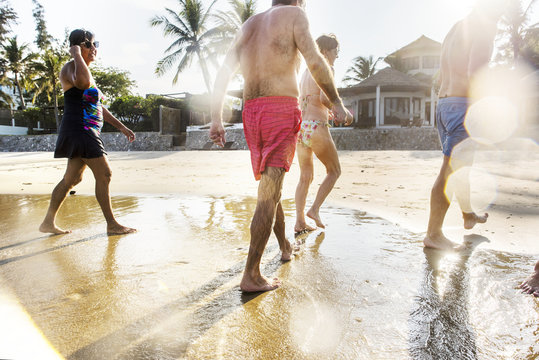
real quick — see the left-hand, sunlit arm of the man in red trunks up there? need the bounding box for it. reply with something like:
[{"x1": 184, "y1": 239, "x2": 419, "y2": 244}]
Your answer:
[{"x1": 210, "y1": 31, "x2": 241, "y2": 146}]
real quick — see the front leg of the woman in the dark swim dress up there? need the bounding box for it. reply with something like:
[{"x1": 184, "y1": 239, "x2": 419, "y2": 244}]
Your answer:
[{"x1": 83, "y1": 155, "x2": 136, "y2": 235}]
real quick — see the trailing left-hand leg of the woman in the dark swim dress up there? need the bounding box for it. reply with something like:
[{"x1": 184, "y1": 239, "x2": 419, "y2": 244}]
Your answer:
[{"x1": 39, "y1": 158, "x2": 86, "y2": 234}]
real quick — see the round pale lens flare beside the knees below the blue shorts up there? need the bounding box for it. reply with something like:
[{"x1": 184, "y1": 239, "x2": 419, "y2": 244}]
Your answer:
[{"x1": 445, "y1": 166, "x2": 498, "y2": 213}]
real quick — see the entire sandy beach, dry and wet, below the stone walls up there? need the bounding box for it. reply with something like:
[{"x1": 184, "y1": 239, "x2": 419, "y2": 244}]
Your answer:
[{"x1": 0, "y1": 151, "x2": 539, "y2": 359}]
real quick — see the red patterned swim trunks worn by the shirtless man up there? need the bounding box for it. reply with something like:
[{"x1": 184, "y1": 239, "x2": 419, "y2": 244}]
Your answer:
[{"x1": 243, "y1": 96, "x2": 301, "y2": 180}]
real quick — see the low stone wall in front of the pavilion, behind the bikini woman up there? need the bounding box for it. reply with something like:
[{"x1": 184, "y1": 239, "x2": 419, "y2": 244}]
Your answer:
[{"x1": 185, "y1": 128, "x2": 440, "y2": 150}]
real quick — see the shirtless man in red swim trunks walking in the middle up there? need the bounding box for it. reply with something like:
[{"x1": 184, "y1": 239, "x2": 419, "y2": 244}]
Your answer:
[{"x1": 210, "y1": 0, "x2": 352, "y2": 292}]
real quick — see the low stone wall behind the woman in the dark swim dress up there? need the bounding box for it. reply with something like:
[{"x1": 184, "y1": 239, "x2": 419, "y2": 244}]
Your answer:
[{"x1": 0, "y1": 132, "x2": 173, "y2": 152}]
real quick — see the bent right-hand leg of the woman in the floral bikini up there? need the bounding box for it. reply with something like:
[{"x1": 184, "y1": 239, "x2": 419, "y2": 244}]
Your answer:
[{"x1": 307, "y1": 126, "x2": 341, "y2": 228}]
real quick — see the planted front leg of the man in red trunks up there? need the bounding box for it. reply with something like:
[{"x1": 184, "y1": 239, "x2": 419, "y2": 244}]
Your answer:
[{"x1": 240, "y1": 167, "x2": 285, "y2": 292}]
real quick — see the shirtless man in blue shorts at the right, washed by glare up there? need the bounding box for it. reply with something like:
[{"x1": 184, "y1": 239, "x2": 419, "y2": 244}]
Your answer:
[{"x1": 423, "y1": 0, "x2": 502, "y2": 250}]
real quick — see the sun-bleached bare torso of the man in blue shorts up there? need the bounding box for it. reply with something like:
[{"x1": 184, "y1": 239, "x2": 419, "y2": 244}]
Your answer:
[{"x1": 439, "y1": 13, "x2": 496, "y2": 98}]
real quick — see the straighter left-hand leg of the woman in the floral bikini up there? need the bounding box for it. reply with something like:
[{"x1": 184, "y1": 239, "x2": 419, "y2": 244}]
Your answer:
[{"x1": 296, "y1": 144, "x2": 315, "y2": 233}]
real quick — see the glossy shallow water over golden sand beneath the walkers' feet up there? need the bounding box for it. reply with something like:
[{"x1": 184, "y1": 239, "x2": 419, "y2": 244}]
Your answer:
[{"x1": 0, "y1": 195, "x2": 539, "y2": 359}]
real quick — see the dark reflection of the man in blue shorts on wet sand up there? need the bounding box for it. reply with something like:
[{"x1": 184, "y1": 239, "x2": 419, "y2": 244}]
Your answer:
[{"x1": 409, "y1": 248, "x2": 477, "y2": 359}]
